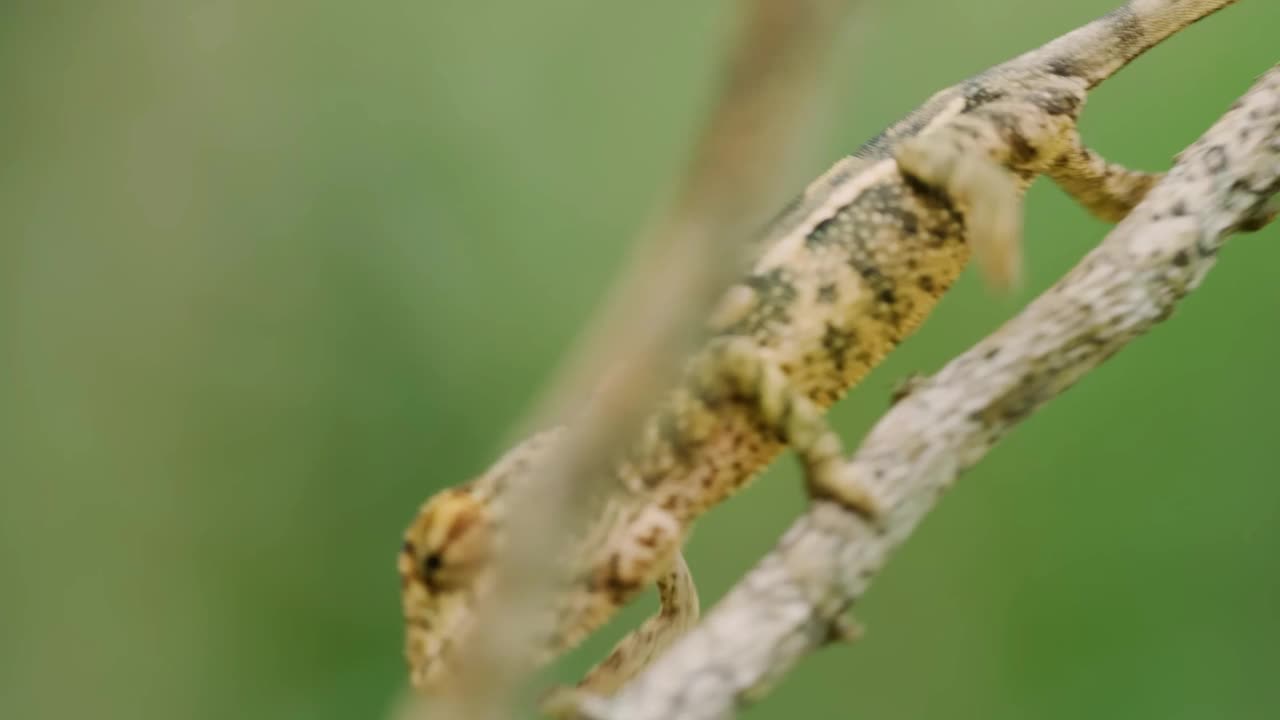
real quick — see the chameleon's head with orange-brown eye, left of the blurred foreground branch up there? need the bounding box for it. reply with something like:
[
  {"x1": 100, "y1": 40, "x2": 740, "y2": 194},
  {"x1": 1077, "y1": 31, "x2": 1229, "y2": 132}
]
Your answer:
[{"x1": 397, "y1": 430, "x2": 559, "y2": 692}]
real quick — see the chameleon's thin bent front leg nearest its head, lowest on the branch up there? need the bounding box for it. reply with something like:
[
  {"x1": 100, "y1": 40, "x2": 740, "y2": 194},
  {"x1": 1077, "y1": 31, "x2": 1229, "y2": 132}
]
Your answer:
[{"x1": 541, "y1": 553, "x2": 699, "y2": 717}]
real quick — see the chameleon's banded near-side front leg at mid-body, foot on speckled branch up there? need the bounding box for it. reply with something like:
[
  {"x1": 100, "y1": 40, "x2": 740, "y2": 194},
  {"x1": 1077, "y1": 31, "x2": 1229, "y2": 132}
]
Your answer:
[{"x1": 694, "y1": 337, "x2": 882, "y2": 521}]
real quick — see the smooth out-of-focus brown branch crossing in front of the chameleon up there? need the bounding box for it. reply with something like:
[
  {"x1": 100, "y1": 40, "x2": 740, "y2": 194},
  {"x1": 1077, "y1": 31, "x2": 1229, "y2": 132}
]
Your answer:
[{"x1": 424, "y1": 0, "x2": 854, "y2": 719}]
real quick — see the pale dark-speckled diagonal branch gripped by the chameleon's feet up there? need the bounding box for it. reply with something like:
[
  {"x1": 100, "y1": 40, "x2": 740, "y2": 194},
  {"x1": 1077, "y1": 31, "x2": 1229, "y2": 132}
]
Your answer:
[{"x1": 582, "y1": 65, "x2": 1280, "y2": 720}]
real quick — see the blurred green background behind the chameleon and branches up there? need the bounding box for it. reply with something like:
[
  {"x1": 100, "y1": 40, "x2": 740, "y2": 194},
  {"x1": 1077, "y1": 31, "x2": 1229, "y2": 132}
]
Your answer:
[{"x1": 0, "y1": 0, "x2": 1280, "y2": 720}]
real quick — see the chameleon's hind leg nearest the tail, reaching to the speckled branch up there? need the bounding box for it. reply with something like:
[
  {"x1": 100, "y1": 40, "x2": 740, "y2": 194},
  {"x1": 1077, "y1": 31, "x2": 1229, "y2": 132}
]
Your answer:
[{"x1": 1046, "y1": 133, "x2": 1162, "y2": 223}]
